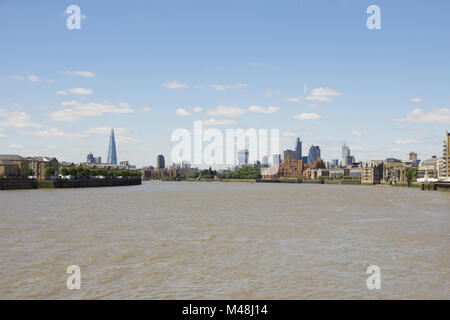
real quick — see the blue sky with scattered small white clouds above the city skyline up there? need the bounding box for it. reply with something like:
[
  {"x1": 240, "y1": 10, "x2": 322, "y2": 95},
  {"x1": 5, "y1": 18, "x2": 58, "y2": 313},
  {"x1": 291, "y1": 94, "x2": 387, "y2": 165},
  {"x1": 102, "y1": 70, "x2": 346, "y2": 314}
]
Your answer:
[{"x1": 0, "y1": 0, "x2": 450, "y2": 167}]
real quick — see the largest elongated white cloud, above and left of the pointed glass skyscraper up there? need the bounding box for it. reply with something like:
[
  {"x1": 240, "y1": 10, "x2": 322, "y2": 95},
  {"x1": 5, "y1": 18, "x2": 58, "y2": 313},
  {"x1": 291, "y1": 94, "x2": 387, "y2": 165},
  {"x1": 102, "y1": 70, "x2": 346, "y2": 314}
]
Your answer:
[{"x1": 50, "y1": 100, "x2": 134, "y2": 122}]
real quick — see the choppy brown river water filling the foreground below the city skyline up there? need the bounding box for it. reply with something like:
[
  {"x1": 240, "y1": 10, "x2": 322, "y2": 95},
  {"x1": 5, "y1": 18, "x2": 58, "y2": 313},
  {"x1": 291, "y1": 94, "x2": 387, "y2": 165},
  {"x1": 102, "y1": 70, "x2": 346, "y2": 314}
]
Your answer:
[{"x1": 0, "y1": 182, "x2": 450, "y2": 299}]
